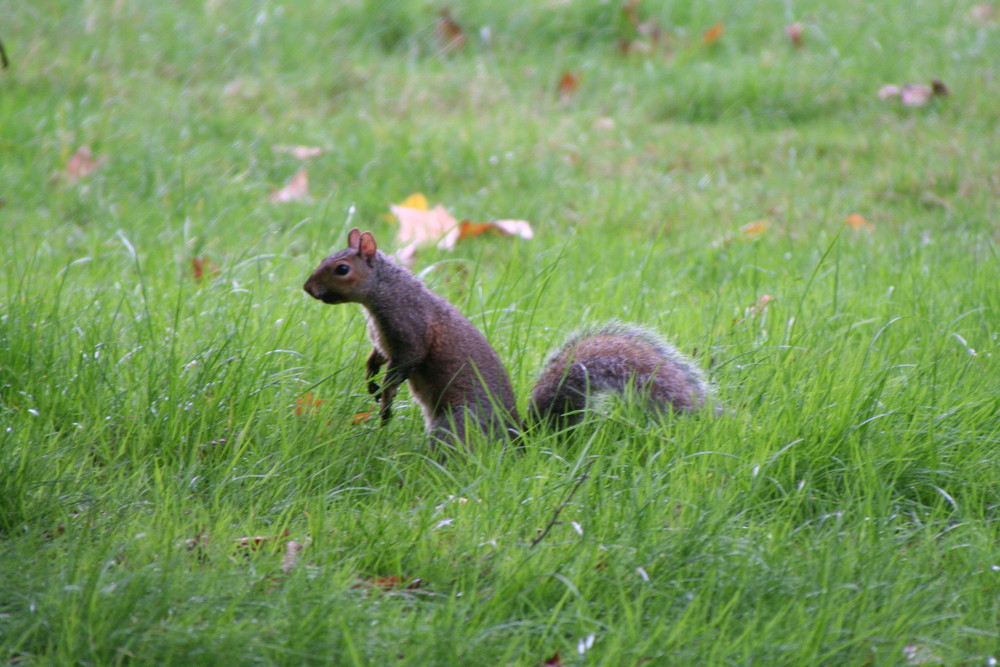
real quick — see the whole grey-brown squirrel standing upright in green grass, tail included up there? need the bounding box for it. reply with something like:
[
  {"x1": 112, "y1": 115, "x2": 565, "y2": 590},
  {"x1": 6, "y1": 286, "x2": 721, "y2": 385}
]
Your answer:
[{"x1": 303, "y1": 228, "x2": 708, "y2": 447}]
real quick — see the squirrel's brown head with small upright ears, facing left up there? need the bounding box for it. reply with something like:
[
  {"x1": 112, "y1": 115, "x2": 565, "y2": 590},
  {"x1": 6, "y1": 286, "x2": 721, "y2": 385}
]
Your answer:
[{"x1": 302, "y1": 228, "x2": 378, "y2": 304}]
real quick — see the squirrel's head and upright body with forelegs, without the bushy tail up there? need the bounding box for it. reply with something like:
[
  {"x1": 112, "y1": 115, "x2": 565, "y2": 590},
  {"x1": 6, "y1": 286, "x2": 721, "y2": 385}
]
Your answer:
[{"x1": 303, "y1": 229, "x2": 519, "y2": 452}]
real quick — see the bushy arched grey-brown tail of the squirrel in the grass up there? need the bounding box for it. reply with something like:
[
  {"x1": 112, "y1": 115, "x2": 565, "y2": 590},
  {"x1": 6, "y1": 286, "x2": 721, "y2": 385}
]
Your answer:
[{"x1": 528, "y1": 322, "x2": 708, "y2": 426}]
